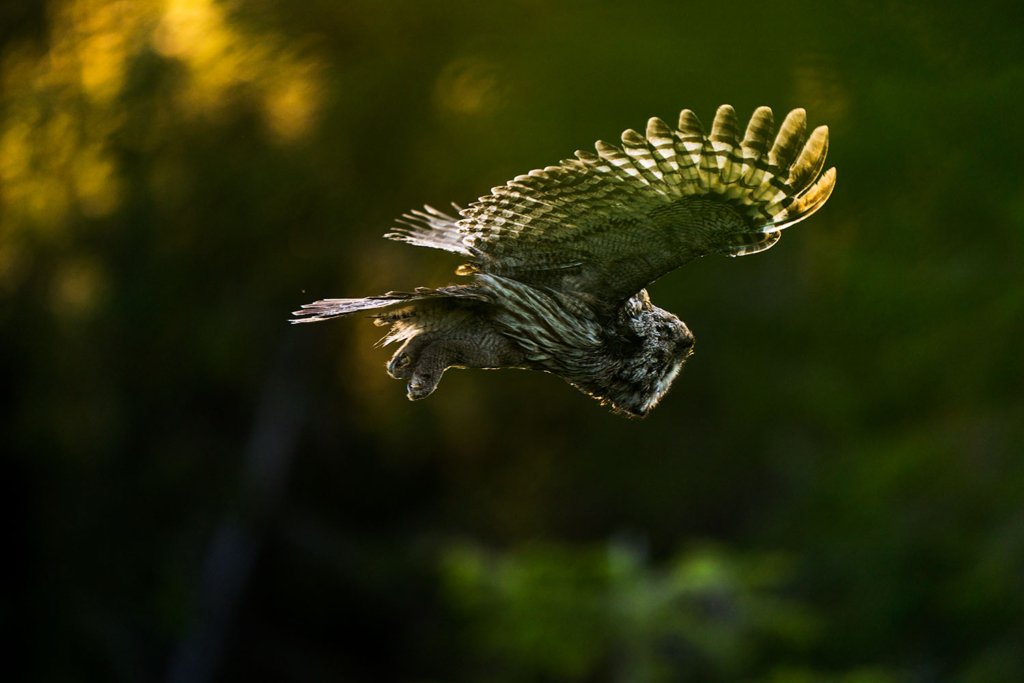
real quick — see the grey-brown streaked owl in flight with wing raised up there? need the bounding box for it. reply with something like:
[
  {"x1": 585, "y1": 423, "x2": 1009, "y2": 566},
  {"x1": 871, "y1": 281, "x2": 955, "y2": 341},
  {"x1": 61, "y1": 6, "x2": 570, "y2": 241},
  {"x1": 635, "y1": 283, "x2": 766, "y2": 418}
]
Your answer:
[{"x1": 292, "y1": 104, "x2": 836, "y2": 417}]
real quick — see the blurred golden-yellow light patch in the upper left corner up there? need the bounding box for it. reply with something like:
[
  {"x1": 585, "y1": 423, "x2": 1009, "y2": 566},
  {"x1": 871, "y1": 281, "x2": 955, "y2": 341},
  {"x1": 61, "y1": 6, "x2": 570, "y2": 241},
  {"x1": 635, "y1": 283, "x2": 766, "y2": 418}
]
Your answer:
[{"x1": 0, "y1": 0, "x2": 323, "y2": 301}]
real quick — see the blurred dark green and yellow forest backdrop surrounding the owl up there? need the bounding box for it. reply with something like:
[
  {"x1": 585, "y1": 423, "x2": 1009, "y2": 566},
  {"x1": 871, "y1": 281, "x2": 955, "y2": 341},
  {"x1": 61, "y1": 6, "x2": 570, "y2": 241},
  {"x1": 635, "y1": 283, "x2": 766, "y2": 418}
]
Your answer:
[{"x1": 0, "y1": 0, "x2": 1024, "y2": 683}]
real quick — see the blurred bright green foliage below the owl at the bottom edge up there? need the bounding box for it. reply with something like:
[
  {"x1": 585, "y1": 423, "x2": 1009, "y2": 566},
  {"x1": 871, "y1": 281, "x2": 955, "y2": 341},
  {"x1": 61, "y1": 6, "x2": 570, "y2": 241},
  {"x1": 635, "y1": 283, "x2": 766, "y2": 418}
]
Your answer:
[{"x1": 443, "y1": 541, "x2": 816, "y2": 681}]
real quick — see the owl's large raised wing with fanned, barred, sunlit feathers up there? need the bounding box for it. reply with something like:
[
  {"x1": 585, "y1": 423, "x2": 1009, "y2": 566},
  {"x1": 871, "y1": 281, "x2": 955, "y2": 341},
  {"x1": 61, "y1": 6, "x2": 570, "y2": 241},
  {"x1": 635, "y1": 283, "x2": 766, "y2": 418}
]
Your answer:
[{"x1": 428, "y1": 104, "x2": 836, "y2": 305}]
